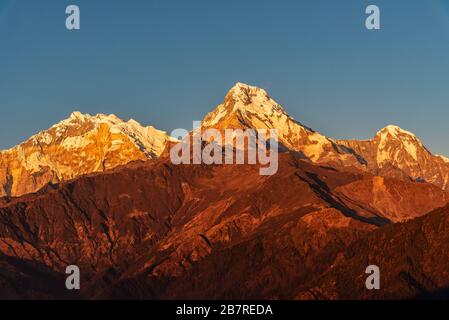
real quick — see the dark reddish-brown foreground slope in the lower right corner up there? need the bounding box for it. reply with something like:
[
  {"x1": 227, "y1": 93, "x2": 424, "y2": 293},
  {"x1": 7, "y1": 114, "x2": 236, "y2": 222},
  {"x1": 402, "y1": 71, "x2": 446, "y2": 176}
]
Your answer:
[{"x1": 296, "y1": 207, "x2": 449, "y2": 299}]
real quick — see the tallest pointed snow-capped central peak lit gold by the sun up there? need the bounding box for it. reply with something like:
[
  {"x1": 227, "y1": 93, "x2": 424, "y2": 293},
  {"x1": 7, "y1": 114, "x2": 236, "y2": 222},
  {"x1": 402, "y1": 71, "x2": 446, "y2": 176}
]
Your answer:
[{"x1": 202, "y1": 83, "x2": 363, "y2": 167}]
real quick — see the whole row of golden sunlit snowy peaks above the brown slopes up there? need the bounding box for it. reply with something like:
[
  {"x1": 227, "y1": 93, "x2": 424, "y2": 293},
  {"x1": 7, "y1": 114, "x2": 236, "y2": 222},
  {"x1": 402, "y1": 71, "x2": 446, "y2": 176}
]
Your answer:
[{"x1": 0, "y1": 82, "x2": 449, "y2": 196}]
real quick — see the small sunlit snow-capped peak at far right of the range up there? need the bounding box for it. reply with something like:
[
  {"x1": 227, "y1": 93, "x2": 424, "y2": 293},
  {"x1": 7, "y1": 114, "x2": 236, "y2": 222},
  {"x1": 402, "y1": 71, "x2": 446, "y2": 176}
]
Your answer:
[{"x1": 338, "y1": 126, "x2": 449, "y2": 189}]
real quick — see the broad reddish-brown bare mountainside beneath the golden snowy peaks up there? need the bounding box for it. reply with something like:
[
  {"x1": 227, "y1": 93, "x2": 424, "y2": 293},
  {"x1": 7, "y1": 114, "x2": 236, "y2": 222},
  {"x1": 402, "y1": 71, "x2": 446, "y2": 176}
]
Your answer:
[{"x1": 0, "y1": 153, "x2": 447, "y2": 299}]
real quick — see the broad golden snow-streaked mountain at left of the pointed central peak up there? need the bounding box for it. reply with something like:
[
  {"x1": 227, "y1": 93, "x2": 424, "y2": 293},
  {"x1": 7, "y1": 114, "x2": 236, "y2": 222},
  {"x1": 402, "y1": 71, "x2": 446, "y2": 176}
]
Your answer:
[{"x1": 0, "y1": 112, "x2": 169, "y2": 196}]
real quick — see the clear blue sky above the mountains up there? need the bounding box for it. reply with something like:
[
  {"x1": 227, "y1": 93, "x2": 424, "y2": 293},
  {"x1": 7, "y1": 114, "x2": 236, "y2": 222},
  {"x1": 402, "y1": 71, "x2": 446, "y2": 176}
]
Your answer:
[{"x1": 0, "y1": 0, "x2": 449, "y2": 155}]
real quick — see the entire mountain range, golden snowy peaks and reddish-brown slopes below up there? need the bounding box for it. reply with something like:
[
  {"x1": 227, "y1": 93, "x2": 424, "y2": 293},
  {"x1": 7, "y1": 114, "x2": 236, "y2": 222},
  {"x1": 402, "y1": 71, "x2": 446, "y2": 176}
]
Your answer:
[{"x1": 0, "y1": 83, "x2": 449, "y2": 299}]
